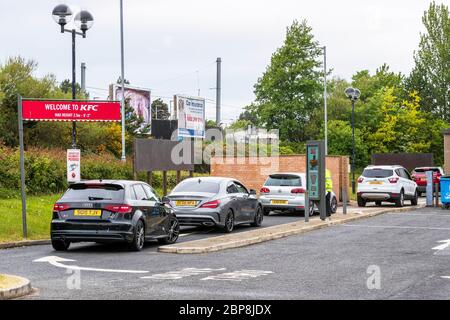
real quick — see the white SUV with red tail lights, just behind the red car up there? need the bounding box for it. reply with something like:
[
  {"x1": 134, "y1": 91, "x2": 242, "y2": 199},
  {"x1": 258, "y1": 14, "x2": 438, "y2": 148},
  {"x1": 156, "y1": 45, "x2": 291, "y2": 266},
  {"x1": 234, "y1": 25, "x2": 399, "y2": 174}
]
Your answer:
[{"x1": 357, "y1": 166, "x2": 418, "y2": 207}]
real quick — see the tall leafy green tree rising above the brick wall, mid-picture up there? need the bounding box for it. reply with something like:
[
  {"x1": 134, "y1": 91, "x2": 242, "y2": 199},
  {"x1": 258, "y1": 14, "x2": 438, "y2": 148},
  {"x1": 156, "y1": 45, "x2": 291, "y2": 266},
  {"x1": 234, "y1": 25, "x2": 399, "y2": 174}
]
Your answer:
[{"x1": 250, "y1": 20, "x2": 323, "y2": 141}]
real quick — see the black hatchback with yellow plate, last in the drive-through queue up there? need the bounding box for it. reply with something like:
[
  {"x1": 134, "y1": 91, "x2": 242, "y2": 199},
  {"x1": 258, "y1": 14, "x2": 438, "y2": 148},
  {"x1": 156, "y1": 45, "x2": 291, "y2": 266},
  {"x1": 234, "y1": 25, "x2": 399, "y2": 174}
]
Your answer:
[{"x1": 51, "y1": 180, "x2": 180, "y2": 251}]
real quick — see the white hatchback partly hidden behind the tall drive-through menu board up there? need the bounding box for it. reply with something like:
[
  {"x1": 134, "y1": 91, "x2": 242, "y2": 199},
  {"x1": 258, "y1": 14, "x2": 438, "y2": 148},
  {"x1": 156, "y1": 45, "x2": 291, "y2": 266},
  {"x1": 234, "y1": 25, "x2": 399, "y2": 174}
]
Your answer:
[{"x1": 259, "y1": 172, "x2": 338, "y2": 216}]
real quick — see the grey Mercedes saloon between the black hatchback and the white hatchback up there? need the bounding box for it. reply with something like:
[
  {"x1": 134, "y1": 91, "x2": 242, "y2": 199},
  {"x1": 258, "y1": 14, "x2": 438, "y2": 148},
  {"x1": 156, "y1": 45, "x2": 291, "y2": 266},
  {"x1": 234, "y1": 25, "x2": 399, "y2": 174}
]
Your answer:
[{"x1": 166, "y1": 177, "x2": 263, "y2": 233}]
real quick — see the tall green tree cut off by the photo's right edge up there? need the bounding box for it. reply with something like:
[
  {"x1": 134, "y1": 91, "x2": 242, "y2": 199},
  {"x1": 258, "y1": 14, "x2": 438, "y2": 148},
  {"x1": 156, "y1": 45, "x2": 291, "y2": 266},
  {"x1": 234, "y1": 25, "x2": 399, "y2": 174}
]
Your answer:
[{"x1": 407, "y1": 1, "x2": 450, "y2": 121}]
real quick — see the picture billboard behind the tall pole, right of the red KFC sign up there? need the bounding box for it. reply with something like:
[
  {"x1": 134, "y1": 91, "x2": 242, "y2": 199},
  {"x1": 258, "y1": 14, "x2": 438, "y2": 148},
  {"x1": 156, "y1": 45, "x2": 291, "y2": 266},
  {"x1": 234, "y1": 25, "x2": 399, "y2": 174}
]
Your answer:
[{"x1": 110, "y1": 84, "x2": 152, "y2": 125}]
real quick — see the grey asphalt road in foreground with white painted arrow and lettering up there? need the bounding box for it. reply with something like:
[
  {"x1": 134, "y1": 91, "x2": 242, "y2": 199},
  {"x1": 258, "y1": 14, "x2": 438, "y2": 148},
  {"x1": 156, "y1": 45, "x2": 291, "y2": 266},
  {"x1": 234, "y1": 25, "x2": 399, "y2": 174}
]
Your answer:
[{"x1": 0, "y1": 202, "x2": 450, "y2": 299}]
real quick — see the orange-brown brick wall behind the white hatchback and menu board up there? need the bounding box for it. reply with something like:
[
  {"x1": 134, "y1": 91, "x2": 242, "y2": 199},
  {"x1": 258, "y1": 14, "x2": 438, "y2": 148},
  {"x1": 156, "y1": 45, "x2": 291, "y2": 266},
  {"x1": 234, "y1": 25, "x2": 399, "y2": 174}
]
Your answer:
[{"x1": 211, "y1": 155, "x2": 349, "y2": 199}]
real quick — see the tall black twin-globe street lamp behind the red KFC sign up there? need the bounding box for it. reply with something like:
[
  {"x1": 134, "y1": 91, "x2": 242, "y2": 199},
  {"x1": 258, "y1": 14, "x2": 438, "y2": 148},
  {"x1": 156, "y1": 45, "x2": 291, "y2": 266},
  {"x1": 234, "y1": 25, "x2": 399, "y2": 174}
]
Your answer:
[{"x1": 52, "y1": 4, "x2": 94, "y2": 149}]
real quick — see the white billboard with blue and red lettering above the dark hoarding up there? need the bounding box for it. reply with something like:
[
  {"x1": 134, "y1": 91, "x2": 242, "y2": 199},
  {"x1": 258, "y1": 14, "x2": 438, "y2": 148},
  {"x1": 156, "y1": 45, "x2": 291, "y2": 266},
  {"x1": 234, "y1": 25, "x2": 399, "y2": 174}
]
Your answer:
[{"x1": 175, "y1": 95, "x2": 205, "y2": 138}]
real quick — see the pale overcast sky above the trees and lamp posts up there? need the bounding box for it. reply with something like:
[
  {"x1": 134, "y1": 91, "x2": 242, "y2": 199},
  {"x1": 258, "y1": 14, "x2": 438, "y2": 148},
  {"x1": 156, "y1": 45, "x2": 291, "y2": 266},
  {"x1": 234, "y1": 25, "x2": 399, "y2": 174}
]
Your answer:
[{"x1": 0, "y1": 0, "x2": 436, "y2": 121}]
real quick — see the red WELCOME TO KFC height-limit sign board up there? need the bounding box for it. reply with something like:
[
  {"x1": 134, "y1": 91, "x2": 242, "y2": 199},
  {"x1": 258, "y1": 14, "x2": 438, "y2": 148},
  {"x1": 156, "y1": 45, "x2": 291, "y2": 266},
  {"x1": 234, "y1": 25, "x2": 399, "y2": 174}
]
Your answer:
[{"x1": 22, "y1": 100, "x2": 121, "y2": 121}]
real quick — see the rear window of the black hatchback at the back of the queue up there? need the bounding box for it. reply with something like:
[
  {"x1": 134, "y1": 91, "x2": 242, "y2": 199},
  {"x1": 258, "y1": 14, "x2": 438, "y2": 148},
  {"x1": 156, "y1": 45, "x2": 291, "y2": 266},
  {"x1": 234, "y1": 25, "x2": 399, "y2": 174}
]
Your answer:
[{"x1": 61, "y1": 183, "x2": 124, "y2": 201}]
